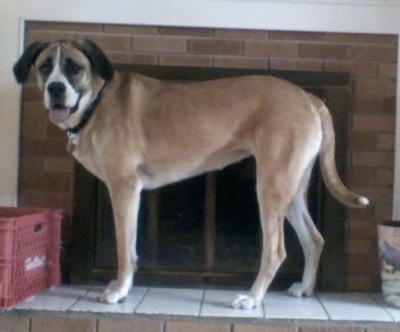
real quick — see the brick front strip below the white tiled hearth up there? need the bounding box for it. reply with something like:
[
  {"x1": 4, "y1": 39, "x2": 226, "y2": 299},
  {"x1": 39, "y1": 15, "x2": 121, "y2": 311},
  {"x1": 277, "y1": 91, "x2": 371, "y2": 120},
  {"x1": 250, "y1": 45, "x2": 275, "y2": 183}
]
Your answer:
[{"x1": 0, "y1": 313, "x2": 398, "y2": 332}]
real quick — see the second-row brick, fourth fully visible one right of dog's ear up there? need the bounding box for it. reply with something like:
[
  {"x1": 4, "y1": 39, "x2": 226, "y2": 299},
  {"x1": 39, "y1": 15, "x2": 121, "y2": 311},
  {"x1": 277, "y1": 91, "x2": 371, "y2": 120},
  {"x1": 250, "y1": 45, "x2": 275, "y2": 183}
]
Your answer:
[{"x1": 299, "y1": 44, "x2": 351, "y2": 59}]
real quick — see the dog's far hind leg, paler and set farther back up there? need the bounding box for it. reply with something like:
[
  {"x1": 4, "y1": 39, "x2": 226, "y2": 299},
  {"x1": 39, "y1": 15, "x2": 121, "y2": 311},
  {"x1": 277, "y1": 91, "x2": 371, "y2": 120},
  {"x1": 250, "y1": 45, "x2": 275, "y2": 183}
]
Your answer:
[{"x1": 287, "y1": 165, "x2": 324, "y2": 297}]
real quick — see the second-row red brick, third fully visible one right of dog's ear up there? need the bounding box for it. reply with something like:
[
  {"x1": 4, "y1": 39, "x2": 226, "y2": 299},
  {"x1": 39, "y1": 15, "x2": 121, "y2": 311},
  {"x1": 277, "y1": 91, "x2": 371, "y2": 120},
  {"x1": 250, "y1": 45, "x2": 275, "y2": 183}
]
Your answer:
[{"x1": 245, "y1": 40, "x2": 298, "y2": 58}]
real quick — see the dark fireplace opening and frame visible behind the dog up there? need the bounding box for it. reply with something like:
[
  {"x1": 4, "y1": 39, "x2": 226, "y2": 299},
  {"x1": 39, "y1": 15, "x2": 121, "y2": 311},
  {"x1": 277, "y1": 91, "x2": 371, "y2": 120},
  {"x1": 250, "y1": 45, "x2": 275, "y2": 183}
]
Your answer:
[{"x1": 69, "y1": 65, "x2": 351, "y2": 290}]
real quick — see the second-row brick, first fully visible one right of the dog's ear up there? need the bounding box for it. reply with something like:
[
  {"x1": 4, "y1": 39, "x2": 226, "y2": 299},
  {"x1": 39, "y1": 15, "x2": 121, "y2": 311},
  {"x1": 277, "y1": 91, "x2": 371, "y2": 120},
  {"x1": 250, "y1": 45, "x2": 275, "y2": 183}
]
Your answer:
[{"x1": 133, "y1": 36, "x2": 187, "y2": 53}]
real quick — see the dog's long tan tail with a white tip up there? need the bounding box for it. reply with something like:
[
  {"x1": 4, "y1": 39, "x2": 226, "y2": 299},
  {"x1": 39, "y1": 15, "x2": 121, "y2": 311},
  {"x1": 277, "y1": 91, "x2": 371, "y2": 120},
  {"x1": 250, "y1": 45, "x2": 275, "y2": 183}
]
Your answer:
[{"x1": 313, "y1": 97, "x2": 369, "y2": 207}]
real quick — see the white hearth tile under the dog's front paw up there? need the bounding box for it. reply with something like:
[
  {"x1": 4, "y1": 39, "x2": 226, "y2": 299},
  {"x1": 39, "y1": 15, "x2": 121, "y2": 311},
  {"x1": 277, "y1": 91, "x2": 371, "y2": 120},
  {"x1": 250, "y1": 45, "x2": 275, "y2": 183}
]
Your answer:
[{"x1": 70, "y1": 287, "x2": 147, "y2": 314}]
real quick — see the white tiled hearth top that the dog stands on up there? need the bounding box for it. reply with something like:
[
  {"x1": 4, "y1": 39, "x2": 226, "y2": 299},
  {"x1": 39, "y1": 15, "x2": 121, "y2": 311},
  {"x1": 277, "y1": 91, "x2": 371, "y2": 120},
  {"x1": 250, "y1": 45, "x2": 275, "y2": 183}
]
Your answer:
[{"x1": 5, "y1": 286, "x2": 400, "y2": 322}]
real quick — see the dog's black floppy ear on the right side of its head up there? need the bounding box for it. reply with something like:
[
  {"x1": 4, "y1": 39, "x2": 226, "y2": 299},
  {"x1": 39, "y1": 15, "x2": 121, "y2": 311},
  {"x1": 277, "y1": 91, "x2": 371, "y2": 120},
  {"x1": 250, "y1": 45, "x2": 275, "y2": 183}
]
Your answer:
[{"x1": 76, "y1": 39, "x2": 114, "y2": 81}]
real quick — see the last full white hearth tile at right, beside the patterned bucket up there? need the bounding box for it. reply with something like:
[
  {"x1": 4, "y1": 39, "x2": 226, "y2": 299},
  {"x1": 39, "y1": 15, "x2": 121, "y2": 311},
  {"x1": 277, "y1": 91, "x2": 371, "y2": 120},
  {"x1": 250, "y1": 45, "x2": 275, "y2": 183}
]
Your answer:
[{"x1": 318, "y1": 293, "x2": 393, "y2": 322}]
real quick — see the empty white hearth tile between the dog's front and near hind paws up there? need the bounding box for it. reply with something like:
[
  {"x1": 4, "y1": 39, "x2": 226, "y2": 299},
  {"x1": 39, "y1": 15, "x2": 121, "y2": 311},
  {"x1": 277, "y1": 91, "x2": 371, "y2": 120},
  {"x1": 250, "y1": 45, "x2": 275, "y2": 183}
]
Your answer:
[{"x1": 135, "y1": 288, "x2": 204, "y2": 316}]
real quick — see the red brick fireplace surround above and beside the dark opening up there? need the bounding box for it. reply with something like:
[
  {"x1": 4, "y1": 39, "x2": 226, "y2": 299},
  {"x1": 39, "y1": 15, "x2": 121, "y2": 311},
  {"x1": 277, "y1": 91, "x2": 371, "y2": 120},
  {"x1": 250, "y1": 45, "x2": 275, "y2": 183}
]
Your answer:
[{"x1": 19, "y1": 22, "x2": 397, "y2": 290}]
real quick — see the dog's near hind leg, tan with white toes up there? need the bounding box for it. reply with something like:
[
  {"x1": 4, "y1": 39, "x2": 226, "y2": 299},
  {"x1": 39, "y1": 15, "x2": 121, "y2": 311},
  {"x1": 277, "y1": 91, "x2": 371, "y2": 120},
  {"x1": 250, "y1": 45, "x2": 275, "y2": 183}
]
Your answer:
[{"x1": 232, "y1": 147, "x2": 299, "y2": 309}]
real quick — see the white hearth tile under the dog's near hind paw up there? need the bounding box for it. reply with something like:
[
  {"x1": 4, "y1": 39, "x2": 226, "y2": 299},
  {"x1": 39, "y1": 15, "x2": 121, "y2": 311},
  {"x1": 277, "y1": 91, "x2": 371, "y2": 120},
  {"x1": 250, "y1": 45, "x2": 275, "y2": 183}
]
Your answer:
[{"x1": 200, "y1": 290, "x2": 263, "y2": 318}]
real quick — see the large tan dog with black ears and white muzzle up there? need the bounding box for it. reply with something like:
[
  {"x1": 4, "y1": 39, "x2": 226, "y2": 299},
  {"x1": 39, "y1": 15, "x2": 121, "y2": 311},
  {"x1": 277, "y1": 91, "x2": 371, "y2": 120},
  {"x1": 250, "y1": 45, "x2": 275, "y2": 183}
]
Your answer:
[{"x1": 13, "y1": 40, "x2": 369, "y2": 309}]
